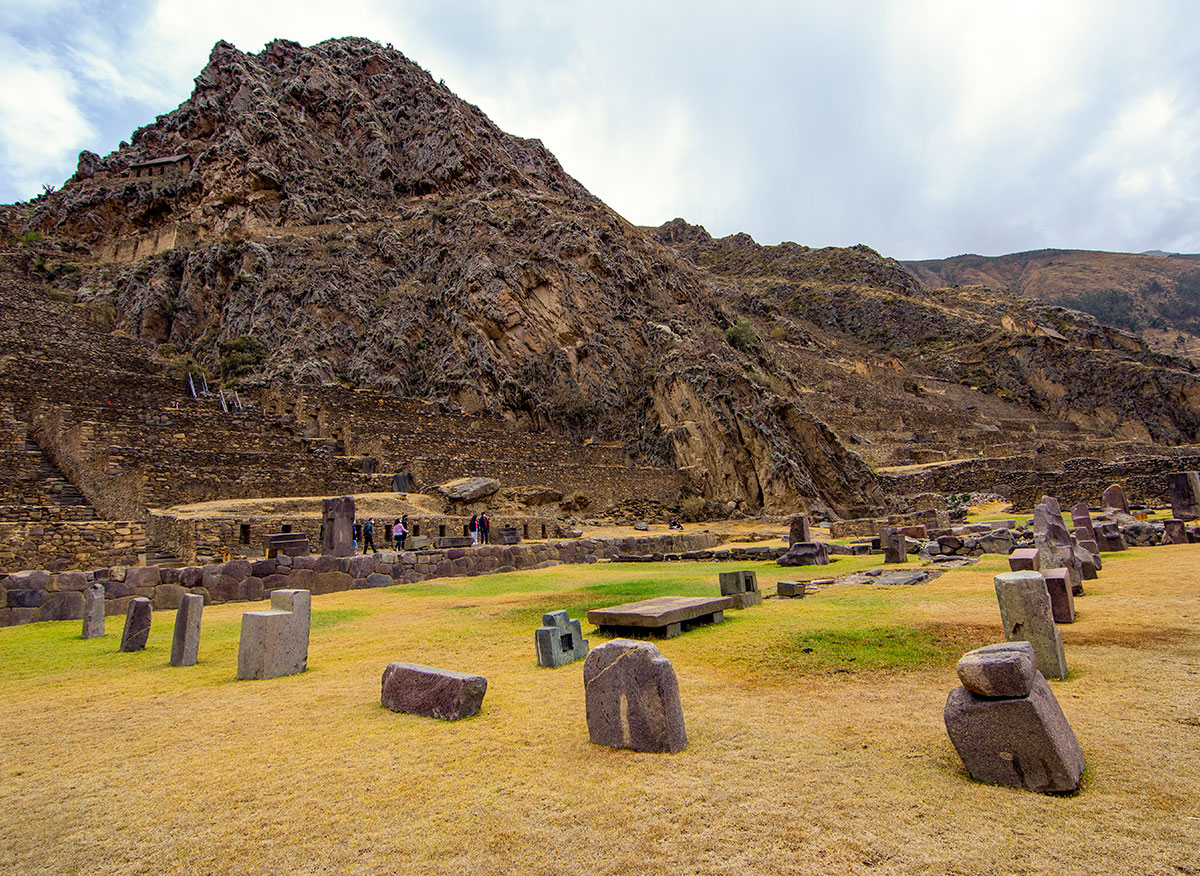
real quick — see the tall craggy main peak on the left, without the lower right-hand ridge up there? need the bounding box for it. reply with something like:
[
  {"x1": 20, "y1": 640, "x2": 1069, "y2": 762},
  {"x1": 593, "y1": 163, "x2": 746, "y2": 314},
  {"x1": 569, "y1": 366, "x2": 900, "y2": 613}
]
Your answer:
[{"x1": 6, "y1": 40, "x2": 883, "y2": 514}]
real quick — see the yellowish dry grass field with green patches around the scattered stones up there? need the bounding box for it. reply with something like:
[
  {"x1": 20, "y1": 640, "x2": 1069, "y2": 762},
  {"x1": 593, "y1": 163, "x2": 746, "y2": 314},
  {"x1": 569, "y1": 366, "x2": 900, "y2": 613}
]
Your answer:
[{"x1": 0, "y1": 546, "x2": 1200, "y2": 876}]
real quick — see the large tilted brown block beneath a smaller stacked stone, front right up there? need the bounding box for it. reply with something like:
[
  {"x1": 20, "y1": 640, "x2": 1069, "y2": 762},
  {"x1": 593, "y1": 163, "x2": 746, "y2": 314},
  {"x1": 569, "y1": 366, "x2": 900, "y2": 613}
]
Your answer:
[{"x1": 943, "y1": 673, "x2": 1084, "y2": 793}]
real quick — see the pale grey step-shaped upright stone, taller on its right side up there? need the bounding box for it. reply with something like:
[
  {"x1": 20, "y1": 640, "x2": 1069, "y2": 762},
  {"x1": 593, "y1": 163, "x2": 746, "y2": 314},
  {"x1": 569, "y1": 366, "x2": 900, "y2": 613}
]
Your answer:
[{"x1": 238, "y1": 590, "x2": 311, "y2": 678}]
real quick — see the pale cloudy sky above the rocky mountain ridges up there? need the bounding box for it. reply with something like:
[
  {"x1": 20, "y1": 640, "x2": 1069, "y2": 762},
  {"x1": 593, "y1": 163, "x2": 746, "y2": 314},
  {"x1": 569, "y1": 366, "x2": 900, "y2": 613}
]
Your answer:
[{"x1": 0, "y1": 0, "x2": 1200, "y2": 258}]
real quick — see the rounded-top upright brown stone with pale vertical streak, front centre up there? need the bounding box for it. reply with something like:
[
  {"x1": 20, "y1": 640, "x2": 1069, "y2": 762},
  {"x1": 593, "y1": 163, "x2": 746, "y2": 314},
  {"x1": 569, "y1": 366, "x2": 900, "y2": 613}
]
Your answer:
[{"x1": 583, "y1": 638, "x2": 688, "y2": 754}]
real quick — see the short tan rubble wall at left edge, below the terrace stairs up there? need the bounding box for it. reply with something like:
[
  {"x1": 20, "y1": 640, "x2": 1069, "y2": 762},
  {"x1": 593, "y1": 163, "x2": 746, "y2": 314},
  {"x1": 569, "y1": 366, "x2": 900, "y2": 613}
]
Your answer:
[{"x1": 0, "y1": 520, "x2": 146, "y2": 572}]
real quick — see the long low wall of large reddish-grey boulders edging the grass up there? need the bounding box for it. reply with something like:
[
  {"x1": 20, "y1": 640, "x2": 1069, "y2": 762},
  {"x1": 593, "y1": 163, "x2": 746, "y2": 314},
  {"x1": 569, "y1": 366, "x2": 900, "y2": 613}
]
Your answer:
[{"x1": 0, "y1": 524, "x2": 720, "y2": 626}]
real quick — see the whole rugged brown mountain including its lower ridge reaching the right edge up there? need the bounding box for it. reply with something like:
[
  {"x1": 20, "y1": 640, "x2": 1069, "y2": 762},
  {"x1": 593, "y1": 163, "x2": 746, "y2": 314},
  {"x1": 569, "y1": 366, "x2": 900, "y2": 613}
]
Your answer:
[{"x1": 0, "y1": 38, "x2": 1200, "y2": 515}]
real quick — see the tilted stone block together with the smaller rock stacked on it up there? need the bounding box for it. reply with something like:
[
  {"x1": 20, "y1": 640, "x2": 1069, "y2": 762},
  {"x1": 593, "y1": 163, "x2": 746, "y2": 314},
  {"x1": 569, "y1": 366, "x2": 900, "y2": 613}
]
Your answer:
[{"x1": 943, "y1": 642, "x2": 1084, "y2": 793}]
